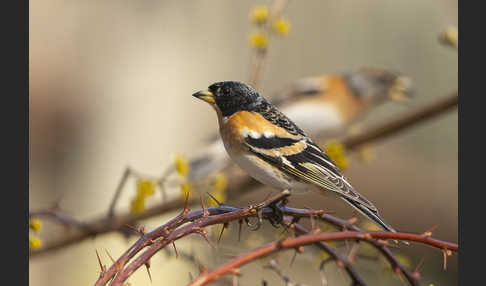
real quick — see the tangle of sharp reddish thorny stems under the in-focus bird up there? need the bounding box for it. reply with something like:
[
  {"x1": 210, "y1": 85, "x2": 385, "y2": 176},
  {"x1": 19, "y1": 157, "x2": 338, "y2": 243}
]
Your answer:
[{"x1": 90, "y1": 191, "x2": 458, "y2": 286}]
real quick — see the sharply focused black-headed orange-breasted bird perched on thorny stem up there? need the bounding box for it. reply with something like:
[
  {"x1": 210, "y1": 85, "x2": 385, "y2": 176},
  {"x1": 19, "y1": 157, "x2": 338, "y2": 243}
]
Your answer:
[{"x1": 193, "y1": 81, "x2": 395, "y2": 232}]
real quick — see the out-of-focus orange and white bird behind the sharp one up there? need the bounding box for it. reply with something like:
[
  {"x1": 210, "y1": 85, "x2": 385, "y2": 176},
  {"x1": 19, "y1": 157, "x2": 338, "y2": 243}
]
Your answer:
[{"x1": 189, "y1": 67, "x2": 412, "y2": 181}]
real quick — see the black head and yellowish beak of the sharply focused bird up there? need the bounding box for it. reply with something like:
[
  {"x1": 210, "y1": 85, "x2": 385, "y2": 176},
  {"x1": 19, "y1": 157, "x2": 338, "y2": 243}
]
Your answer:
[{"x1": 193, "y1": 81, "x2": 267, "y2": 117}]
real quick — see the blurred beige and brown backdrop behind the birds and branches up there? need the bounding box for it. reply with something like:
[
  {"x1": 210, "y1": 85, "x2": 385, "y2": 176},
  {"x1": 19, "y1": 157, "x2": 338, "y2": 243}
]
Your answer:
[{"x1": 29, "y1": 0, "x2": 458, "y2": 285}]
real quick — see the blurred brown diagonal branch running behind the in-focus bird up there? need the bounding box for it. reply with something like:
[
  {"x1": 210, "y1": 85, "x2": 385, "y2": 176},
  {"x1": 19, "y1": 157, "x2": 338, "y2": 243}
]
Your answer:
[{"x1": 29, "y1": 89, "x2": 458, "y2": 257}]
